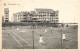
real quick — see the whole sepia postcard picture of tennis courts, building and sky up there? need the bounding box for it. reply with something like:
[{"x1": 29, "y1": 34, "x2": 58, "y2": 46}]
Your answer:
[{"x1": 1, "y1": 0, "x2": 79, "y2": 49}]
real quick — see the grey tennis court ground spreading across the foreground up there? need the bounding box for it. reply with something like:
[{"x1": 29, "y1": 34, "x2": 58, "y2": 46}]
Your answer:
[{"x1": 2, "y1": 26, "x2": 78, "y2": 49}]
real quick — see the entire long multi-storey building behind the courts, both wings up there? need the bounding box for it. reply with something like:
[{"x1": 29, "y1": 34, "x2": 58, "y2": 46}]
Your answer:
[{"x1": 13, "y1": 9, "x2": 59, "y2": 23}]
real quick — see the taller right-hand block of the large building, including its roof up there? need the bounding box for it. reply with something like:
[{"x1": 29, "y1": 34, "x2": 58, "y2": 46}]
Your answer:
[{"x1": 35, "y1": 9, "x2": 58, "y2": 23}]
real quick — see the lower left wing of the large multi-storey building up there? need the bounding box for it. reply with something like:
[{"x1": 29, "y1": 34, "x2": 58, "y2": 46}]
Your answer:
[{"x1": 13, "y1": 11, "x2": 32, "y2": 22}]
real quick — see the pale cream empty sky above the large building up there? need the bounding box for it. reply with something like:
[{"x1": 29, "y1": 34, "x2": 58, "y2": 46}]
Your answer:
[{"x1": 3, "y1": 0, "x2": 80, "y2": 23}]
